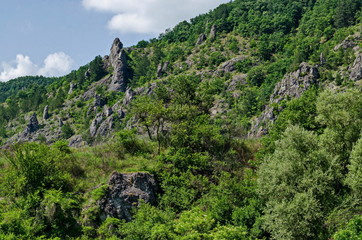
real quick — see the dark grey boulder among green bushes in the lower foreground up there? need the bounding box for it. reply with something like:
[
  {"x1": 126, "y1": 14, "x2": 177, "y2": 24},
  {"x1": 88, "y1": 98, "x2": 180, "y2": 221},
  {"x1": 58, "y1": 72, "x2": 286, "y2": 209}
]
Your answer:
[{"x1": 98, "y1": 172, "x2": 158, "y2": 221}]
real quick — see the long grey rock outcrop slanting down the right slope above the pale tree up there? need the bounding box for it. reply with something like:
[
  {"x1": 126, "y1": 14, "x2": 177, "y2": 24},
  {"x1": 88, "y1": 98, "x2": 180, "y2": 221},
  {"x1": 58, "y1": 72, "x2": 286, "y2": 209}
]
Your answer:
[{"x1": 249, "y1": 62, "x2": 319, "y2": 138}]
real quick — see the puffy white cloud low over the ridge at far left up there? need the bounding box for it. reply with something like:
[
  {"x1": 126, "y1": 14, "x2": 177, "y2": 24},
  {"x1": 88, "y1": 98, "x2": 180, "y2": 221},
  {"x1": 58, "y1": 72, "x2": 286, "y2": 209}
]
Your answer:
[{"x1": 0, "y1": 52, "x2": 73, "y2": 81}]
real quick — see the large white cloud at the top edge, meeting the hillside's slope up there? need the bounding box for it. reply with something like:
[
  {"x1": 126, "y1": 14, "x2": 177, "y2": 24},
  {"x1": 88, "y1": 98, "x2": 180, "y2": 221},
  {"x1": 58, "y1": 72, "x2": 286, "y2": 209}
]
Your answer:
[{"x1": 83, "y1": 0, "x2": 229, "y2": 33}]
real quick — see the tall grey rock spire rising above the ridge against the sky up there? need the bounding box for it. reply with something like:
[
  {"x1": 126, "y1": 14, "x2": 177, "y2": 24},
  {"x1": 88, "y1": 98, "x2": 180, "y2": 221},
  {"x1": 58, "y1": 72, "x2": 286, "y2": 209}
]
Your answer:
[{"x1": 108, "y1": 38, "x2": 128, "y2": 92}]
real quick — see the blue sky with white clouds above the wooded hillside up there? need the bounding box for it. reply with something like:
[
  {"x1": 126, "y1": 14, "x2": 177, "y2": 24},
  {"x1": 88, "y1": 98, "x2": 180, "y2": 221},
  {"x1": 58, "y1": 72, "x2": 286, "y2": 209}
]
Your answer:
[{"x1": 0, "y1": 0, "x2": 229, "y2": 81}]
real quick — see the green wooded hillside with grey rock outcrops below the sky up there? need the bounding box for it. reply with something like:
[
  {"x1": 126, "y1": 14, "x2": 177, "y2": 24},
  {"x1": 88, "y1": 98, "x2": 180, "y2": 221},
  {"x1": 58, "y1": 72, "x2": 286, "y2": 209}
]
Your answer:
[{"x1": 0, "y1": 0, "x2": 362, "y2": 240}]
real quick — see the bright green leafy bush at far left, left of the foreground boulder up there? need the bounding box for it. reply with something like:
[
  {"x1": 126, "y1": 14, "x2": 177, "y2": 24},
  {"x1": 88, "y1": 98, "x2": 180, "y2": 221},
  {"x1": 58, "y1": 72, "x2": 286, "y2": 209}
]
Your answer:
[{"x1": 3, "y1": 143, "x2": 71, "y2": 196}]
